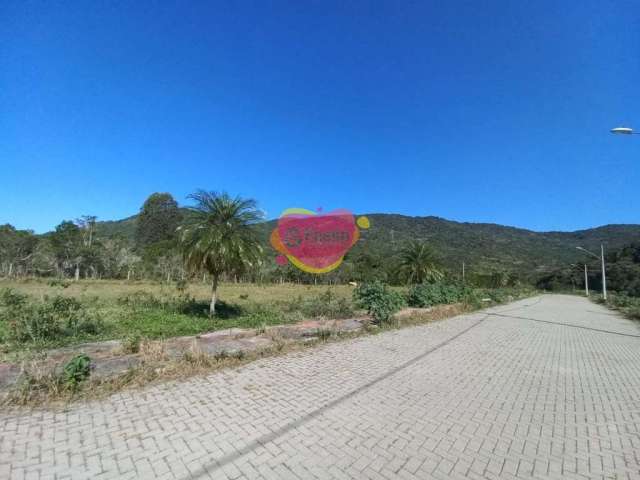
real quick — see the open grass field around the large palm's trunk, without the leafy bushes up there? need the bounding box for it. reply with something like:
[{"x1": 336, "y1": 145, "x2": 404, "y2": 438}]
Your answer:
[{"x1": 0, "y1": 279, "x2": 354, "y2": 356}]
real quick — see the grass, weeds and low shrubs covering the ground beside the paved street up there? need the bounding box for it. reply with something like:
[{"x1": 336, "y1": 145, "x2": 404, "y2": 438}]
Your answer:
[{"x1": 0, "y1": 282, "x2": 536, "y2": 405}]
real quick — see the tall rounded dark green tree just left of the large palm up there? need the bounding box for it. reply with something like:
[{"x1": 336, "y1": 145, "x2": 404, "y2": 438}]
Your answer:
[{"x1": 136, "y1": 193, "x2": 181, "y2": 250}]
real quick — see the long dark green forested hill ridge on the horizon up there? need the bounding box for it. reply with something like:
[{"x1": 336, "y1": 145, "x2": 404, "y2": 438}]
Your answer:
[{"x1": 96, "y1": 213, "x2": 640, "y2": 274}]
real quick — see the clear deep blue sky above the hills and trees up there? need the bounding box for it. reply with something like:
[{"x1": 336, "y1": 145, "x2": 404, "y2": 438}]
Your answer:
[{"x1": 0, "y1": 0, "x2": 640, "y2": 232}]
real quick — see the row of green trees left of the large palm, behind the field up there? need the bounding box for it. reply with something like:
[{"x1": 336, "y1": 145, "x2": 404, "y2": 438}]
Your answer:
[{"x1": 0, "y1": 193, "x2": 184, "y2": 280}]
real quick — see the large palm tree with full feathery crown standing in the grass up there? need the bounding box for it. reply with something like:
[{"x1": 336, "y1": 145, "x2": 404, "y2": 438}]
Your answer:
[{"x1": 178, "y1": 190, "x2": 263, "y2": 317}]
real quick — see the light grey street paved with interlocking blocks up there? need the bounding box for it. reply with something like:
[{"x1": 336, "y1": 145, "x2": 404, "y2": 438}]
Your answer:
[{"x1": 0, "y1": 295, "x2": 640, "y2": 480}]
